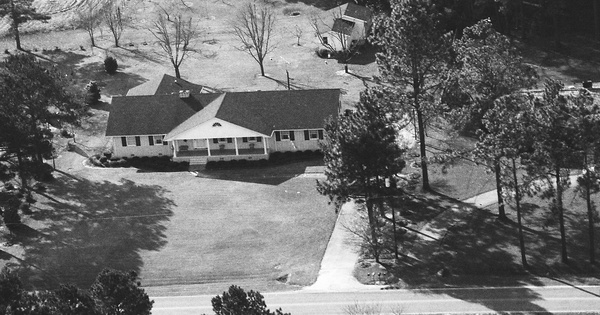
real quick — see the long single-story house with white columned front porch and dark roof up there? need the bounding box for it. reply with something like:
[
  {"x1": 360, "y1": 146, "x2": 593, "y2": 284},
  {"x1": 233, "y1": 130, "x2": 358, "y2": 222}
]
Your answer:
[{"x1": 106, "y1": 78, "x2": 340, "y2": 164}]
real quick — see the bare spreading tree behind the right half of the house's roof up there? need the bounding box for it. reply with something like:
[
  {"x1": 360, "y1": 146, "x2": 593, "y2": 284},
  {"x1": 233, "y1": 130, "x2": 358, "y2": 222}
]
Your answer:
[{"x1": 232, "y1": 2, "x2": 276, "y2": 76}]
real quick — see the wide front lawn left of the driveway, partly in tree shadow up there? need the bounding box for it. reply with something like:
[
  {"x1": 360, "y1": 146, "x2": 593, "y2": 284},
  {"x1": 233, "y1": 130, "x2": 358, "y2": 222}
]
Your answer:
[{"x1": 2, "y1": 165, "x2": 336, "y2": 293}]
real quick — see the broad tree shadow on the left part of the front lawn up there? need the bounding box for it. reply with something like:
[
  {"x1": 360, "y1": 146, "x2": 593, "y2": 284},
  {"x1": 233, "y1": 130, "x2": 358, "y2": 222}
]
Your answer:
[{"x1": 10, "y1": 176, "x2": 175, "y2": 289}]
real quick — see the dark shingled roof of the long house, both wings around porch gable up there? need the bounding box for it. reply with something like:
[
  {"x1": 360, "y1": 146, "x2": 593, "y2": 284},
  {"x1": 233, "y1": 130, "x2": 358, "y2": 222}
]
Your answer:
[{"x1": 106, "y1": 89, "x2": 340, "y2": 136}]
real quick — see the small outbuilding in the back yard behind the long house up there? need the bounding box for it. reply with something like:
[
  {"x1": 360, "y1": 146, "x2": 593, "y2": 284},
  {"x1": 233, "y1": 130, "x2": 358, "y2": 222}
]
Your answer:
[{"x1": 316, "y1": 2, "x2": 372, "y2": 51}]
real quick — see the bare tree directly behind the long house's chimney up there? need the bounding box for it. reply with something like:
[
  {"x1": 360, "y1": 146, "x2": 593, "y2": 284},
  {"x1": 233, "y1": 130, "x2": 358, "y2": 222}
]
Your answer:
[{"x1": 150, "y1": 11, "x2": 198, "y2": 78}]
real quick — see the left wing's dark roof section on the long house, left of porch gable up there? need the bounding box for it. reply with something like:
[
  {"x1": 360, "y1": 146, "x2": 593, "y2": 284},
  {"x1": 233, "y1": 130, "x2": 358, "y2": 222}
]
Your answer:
[{"x1": 106, "y1": 94, "x2": 220, "y2": 136}]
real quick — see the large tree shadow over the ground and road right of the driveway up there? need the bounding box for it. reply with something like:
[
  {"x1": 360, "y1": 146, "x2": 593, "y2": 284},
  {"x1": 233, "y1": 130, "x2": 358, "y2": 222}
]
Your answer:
[{"x1": 380, "y1": 189, "x2": 598, "y2": 312}]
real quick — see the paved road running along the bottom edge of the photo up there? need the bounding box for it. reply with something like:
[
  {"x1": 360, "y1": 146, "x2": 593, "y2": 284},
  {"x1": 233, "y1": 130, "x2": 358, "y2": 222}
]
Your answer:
[{"x1": 152, "y1": 286, "x2": 600, "y2": 315}]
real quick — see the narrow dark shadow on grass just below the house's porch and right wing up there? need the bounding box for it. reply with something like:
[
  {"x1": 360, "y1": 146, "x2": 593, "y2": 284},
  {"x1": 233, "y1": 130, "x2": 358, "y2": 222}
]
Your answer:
[{"x1": 197, "y1": 158, "x2": 323, "y2": 186}]
